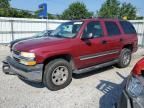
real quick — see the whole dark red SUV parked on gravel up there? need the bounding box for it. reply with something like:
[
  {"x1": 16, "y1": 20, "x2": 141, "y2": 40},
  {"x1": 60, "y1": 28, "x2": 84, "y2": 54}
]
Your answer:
[{"x1": 3, "y1": 18, "x2": 138, "y2": 90}]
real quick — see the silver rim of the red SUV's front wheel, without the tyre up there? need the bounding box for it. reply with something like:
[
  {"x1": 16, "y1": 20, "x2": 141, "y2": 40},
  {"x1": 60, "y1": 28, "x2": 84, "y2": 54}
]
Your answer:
[{"x1": 52, "y1": 66, "x2": 68, "y2": 85}]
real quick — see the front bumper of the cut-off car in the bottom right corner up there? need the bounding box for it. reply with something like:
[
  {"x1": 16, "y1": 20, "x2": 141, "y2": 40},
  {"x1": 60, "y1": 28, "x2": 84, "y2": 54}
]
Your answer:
[{"x1": 114, "y1": 90, "x2": 144, "y2": 108}]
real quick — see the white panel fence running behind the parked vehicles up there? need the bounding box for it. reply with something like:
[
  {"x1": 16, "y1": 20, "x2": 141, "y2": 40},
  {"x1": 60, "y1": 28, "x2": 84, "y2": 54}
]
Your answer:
[{"x1": 0, "y1": 17, "x2": 144, "y2": 46}]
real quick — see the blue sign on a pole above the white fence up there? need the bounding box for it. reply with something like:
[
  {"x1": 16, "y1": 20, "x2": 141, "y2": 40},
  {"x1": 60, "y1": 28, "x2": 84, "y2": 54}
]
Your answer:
[{"x1": 38, "y1": 3, "x2": 47, "y2": 18}]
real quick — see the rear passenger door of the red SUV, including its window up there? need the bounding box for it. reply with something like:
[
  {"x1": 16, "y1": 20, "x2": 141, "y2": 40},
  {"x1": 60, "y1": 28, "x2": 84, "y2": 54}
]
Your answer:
[{"x1": 104, "y1": 21, "x2": 122, "y2": 60}]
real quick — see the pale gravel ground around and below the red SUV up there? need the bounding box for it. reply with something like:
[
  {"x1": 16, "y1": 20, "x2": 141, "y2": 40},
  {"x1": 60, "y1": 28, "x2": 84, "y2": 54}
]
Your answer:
[{"x1": 0, "y1": 46, "x2": 144, "y2": 108}]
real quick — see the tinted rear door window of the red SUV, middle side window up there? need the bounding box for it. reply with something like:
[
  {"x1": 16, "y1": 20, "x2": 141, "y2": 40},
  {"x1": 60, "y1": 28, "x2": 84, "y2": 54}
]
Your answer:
[{"x1": 105, "y1": 21, "x2": 121, "y2": 36}]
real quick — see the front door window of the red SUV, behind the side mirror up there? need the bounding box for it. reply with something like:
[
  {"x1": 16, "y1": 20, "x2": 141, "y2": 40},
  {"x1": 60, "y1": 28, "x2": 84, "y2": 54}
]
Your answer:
[{"x1": 83, "y1": 21, "x2": 103, "y2": 37}]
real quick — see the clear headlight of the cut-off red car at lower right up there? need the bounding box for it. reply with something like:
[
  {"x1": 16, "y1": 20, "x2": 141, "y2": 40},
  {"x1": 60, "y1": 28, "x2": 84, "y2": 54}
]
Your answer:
[{"x1": 127, "y1": 77, "x2": 144, "y2": 97}]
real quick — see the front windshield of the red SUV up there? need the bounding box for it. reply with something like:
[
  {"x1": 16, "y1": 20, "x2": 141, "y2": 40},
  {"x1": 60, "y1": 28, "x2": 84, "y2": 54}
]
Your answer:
[{"x1": 50, "y1": 21, "x2": 83, "y2": 38}]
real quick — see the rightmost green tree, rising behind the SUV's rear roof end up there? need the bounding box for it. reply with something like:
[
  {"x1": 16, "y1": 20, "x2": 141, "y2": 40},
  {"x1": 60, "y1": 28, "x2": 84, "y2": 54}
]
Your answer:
[{"x1": 120, "y1": 3, "x2": 136, "y2": 19}]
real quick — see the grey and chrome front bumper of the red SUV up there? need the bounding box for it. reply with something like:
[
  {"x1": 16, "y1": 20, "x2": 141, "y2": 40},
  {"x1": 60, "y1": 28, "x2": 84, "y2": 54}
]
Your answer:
[{"x1": 3, "y1": 56, "x2": 43, "y2": 82}]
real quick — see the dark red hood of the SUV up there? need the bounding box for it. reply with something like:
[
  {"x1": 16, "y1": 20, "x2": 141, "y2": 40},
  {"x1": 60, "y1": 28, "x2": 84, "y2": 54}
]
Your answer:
[{"x1": 12, "y1": 37, "x2": 68, "y2": 52}]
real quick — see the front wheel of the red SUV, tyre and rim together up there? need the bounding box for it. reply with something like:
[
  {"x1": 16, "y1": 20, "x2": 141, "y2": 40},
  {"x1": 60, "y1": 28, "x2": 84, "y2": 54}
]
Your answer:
[{"x1": 43, "y1": 59, "x2": 72, "y2": 91}]
